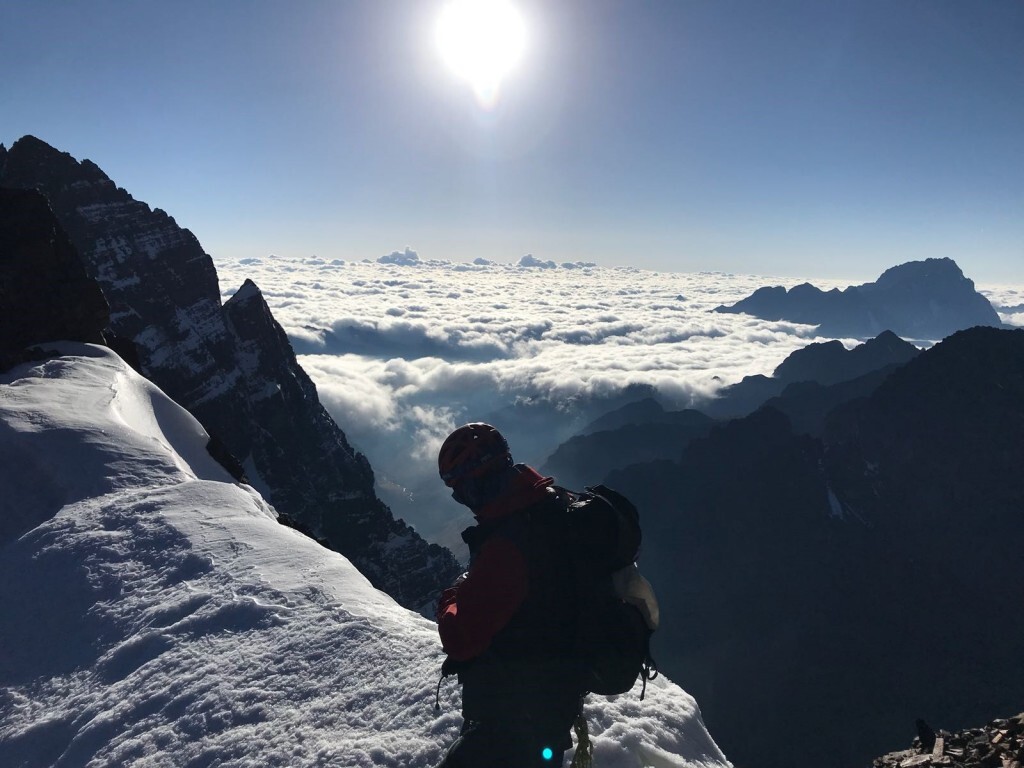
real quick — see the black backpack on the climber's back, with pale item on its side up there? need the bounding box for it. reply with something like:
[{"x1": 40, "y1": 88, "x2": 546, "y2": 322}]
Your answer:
[{"x1": 558, "y1": 485, "x2": 658, "y2": 699}]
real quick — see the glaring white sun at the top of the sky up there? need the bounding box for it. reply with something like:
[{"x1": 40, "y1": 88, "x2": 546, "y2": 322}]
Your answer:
[{"x1": 436, "y1": 0, "x2": 526, "y2": 109}]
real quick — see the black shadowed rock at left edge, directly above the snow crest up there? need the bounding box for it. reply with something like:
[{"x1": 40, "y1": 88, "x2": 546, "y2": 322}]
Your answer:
[{"x1": 0, "y1": 186, "x2": 110, "y2": 371}]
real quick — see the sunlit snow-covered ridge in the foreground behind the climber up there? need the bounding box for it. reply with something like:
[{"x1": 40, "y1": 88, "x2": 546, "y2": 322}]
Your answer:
[{"x1": 0, "y1": 343, "x2": 728, "y2": 768}]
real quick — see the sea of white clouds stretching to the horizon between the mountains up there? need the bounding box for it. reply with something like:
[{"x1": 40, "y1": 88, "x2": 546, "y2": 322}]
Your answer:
[{"x1": 216, "y1": 248, "x2": 1024, "y2": 552}]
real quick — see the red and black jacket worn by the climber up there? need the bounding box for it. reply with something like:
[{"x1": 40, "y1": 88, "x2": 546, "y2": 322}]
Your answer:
[{"x1": 437, "y1": 465, "x2": 582, "y2": 729}]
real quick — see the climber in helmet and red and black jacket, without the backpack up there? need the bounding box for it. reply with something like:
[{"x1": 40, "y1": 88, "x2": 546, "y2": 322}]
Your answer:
[{"x1": 437, "y1": 423, "x2": 585, "y2": 768}]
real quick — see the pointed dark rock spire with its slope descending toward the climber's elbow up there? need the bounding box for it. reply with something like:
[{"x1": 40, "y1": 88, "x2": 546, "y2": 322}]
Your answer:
[{"x1": 224, "y1": 281, "x2": 457, "y2": 607}]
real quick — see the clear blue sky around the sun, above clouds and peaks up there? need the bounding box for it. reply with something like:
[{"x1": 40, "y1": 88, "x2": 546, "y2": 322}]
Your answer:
[{"x1": 0, "y1": 0, "x2": 1024, "y2": 283}]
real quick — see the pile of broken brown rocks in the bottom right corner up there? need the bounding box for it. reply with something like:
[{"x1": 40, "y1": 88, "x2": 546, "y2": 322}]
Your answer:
[{"x1": 871, "y1": 713, "x2": 1024, "y2": 768}]
